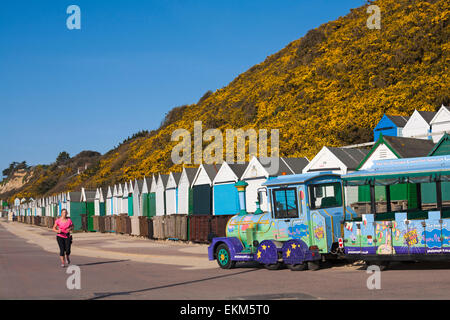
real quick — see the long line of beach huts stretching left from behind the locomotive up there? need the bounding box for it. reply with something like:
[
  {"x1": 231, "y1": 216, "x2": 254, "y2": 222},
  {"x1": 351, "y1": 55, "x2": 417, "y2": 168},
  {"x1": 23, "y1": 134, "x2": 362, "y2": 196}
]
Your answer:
[{"x1": 11, "y1": 157, "x2": 309, "y2": 230}]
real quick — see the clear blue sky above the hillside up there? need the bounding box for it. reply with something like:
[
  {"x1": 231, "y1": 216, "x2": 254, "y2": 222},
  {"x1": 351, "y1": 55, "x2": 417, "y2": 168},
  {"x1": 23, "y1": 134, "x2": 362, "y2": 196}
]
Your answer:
[{"x1": 0, "y1": 0, "x2": 365, "y2": 169}]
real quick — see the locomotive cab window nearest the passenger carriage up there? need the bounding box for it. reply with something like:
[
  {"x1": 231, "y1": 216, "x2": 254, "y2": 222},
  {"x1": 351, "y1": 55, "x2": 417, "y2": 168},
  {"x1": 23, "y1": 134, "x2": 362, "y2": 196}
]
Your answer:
[{"x1": 308, "y1": 182, "x2": 342, "y2": 209}]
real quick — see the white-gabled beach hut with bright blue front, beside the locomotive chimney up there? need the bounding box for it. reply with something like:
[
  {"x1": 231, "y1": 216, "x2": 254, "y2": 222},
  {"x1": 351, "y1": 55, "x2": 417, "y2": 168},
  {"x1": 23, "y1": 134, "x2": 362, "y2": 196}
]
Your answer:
[{"x1": 213, "y1": 162, "x2": 248, "y2": 215}]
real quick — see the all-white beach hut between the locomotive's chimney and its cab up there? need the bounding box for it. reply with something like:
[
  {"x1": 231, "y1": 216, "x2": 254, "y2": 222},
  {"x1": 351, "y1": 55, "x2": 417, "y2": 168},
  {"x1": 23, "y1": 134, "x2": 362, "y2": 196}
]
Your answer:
[{"x1": 241, "y1": 157, "x2": 293, "y2": 212}]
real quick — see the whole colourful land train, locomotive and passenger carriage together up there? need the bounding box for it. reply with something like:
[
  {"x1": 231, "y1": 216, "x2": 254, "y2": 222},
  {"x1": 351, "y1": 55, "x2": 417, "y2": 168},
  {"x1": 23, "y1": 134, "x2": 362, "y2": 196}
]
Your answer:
[{"x1": 208, "y1": 156, "x2": 450, "y2": 270}]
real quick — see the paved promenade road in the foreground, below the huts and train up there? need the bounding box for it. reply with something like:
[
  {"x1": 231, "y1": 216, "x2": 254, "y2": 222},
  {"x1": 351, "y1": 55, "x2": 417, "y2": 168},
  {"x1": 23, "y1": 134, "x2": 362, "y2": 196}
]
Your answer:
[{"x1": 0, "y1": 219, "x2": 450, "y2": 300}]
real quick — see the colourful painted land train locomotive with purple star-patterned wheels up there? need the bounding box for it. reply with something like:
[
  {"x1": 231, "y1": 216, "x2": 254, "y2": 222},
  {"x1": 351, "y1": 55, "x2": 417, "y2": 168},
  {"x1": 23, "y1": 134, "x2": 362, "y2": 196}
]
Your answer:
[{"x1": 208, "y1": 172, "x2": 350, "y2": 270}]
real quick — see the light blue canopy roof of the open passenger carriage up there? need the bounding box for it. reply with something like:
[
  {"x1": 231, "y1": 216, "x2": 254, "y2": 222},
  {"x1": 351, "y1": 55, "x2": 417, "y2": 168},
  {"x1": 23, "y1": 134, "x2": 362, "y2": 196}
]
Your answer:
[{"x1": 342, "y1": 156, "x2": 450, "y2": 184}]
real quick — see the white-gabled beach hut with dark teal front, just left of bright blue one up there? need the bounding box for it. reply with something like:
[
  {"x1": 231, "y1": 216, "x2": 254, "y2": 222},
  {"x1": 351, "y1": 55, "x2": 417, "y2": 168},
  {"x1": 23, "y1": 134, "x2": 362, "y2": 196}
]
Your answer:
[{"x1": 192, "y1": 164, "x2": 221, "y2": 215}]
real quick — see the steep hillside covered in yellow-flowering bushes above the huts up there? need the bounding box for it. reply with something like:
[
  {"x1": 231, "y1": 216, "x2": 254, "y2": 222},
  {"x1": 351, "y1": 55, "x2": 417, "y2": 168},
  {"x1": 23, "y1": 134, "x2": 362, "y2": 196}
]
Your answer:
[{"x1": 2, "y1": 0, "x2": 450, "y2": 202}]
